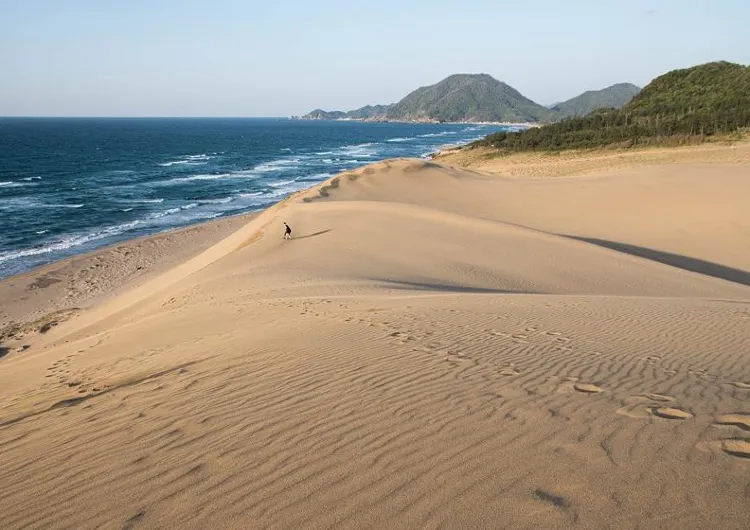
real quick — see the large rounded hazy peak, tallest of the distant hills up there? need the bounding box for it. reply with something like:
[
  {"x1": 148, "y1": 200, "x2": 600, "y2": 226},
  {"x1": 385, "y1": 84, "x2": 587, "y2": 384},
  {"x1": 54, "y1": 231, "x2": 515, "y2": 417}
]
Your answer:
[{"x1": 386, "y1": 74, "x2": 553, "y2": 122}]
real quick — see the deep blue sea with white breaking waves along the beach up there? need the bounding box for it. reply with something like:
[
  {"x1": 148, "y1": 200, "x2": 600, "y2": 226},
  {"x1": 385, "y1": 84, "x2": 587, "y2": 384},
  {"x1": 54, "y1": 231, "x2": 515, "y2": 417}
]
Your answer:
[{"x1": 0, "y1": 118, "x2": 516, "y2": 277}]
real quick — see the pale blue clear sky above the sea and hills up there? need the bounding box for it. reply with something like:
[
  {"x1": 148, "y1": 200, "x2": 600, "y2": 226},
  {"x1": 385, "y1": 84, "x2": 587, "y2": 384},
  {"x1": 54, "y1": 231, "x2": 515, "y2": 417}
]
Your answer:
[{"x1": 0, "y1": 0, "x2": 750, "y2": 117}]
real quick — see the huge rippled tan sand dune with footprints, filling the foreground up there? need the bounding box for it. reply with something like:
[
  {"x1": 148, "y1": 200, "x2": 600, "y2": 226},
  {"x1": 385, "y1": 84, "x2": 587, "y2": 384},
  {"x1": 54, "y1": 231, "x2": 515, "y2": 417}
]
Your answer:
[{"x1": 0, "y1": 148, "x2": 750, "y2": 528}]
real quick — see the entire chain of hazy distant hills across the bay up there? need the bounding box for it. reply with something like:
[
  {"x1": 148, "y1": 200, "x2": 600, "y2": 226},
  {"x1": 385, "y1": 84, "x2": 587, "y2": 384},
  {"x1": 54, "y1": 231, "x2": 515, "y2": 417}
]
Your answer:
[{"x1": 294, "y1": 74, "x2": 640, "y2": 123}]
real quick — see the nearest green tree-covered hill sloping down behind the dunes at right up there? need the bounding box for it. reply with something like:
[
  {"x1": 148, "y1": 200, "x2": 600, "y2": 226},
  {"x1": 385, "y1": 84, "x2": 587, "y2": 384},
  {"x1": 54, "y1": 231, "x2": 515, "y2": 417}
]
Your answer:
[{"x1": 473, "y1": 61, "x2": 750, "y2": 151}]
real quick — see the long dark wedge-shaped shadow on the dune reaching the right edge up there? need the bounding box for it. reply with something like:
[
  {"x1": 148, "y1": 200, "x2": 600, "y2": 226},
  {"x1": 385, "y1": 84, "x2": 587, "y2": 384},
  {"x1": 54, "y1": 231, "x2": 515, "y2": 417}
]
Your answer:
[{"x1": 559, "y1": 234, "x2": 750, "y2": 286}]
